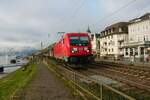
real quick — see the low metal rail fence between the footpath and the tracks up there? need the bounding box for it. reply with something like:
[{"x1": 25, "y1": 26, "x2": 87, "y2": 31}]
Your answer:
[{"x1": 45, "y1": 59, "x2": 135, "y2": 100}]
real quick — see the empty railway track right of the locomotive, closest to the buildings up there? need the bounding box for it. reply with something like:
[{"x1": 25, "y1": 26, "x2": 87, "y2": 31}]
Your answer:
[{"x1": 88, "y1": 64, "x2": 150, "y2": 92}]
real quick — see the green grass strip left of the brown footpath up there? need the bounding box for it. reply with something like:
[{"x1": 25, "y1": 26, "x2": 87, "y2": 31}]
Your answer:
[{"x1": 0, "y1": 63, "x2": 36, "y2": 100}]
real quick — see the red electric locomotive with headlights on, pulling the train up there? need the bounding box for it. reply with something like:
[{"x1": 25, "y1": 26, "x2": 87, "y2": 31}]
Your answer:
[{"x1": 53, "y1": 33, "x2": 92, "y2": 62}]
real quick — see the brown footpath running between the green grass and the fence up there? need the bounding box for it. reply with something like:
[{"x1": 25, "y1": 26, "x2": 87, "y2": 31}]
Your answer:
[{"x1": 20, "y1": 64, "x2": 77, "y2": 100}]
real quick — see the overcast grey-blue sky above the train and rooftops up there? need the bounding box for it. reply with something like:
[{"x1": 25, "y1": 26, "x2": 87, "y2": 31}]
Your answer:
[{"x1": 0, "y1": 0, "x2": 150, "y2": 48}]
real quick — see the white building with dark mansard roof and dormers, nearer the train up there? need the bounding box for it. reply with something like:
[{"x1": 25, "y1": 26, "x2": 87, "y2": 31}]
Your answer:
[{"x1": 100, "y1": 22, "x2": 128, "y2": 59}]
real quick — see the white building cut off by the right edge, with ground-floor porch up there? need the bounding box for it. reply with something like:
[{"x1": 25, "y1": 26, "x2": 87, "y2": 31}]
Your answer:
[{"x1": 124, "y1": 13, "x2": 150, "y2": 61}]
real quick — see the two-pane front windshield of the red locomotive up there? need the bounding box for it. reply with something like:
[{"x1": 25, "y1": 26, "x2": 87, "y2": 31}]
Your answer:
[{"x1": 70, "y1": 36, "x2": 89, "y2": 46}]
